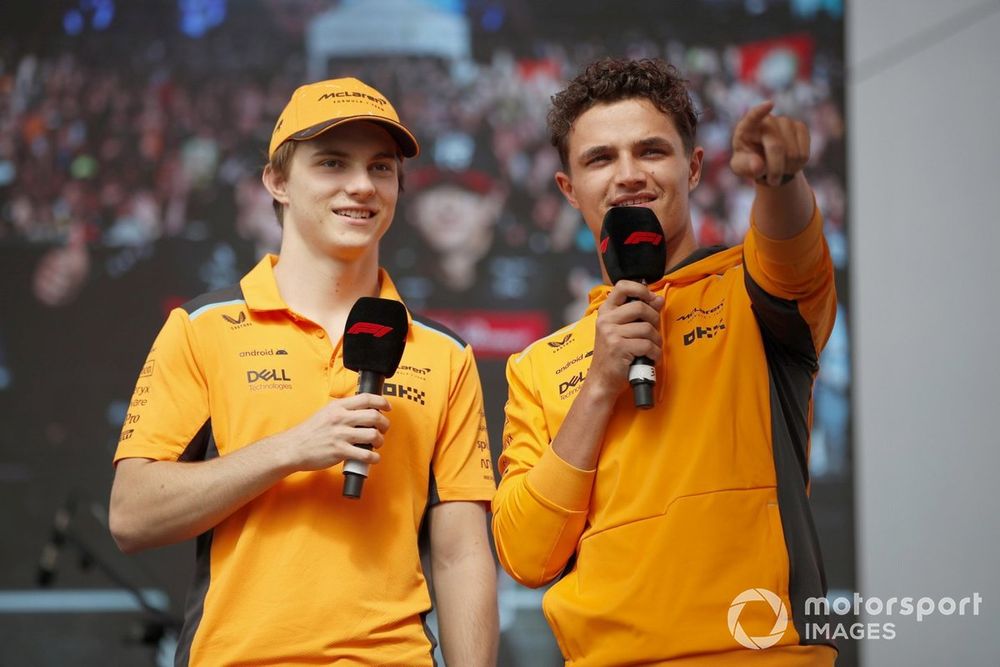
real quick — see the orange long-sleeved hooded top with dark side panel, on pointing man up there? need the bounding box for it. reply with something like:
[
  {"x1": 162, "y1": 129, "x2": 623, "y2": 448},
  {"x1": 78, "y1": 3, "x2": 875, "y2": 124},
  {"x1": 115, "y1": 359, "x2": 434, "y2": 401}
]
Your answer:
[{"x1": 493, "y1": 210, "x2": 836, "y2": 667}]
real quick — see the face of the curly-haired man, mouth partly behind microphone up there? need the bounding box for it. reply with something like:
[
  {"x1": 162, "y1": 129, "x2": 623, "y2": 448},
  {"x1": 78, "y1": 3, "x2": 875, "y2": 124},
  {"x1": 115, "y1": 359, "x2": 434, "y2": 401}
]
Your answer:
[{"x1": 556, "y1": 98, "x2": 704, "y2": 279}]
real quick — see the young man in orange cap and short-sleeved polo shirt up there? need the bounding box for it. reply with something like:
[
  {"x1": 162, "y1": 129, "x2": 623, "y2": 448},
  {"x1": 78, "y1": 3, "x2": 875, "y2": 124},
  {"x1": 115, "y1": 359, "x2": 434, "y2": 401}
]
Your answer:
[{"x1": 111, "y1": 79, "x2": 497, "y2": 665}]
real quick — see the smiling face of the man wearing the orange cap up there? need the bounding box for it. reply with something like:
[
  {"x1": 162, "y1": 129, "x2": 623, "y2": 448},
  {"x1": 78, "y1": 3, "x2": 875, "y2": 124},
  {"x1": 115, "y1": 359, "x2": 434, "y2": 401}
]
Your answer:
[{"x1": 264, "y1": 121, "x2": 400, "y2": 261}]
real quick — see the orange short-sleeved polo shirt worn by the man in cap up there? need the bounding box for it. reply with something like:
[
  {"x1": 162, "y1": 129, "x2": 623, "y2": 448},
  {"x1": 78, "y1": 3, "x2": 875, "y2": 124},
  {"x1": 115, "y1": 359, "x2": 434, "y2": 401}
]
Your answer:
[{"x1": 114, "y1": 256, "x2": 494, "y2": 665}]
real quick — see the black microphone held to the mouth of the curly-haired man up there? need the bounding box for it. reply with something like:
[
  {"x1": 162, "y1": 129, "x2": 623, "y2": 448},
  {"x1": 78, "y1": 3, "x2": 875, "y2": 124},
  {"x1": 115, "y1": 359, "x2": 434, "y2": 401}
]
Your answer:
[{"x1": 601, "y1": 206, "x2": 667, "y2": 410}]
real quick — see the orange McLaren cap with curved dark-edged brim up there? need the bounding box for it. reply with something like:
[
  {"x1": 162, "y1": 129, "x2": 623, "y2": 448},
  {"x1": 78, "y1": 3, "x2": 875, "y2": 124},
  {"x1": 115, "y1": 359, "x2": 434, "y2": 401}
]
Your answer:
[{"x1": 267, "y1": 77, "x2": 420, "y2": 159}]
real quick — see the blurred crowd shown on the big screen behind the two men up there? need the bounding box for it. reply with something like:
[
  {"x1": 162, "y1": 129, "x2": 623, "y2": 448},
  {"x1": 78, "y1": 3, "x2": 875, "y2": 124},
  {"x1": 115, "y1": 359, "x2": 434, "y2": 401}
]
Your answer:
[{"x1": 0, "y1": 0, "x2": 848, "y2": 472}]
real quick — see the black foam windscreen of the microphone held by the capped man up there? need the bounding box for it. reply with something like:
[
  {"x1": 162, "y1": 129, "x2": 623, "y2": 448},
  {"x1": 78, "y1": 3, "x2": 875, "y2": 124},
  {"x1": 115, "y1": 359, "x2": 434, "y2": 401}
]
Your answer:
[{"x1": 344, "y1": 296, "x2": 409, "y2": 377}]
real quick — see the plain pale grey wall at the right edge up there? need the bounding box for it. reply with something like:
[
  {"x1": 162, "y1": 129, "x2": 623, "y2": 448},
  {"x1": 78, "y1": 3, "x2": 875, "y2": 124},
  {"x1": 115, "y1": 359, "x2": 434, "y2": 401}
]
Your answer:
[{"x1": 847, "y1": 0, "x2": 1000, "y2": 667}]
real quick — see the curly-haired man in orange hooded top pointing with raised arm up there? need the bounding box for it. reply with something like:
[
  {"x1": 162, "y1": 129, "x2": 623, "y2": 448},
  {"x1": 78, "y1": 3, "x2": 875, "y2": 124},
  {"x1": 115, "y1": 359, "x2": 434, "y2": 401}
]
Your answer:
[{"x1": 493, "y1": 60, "x2": 836, "y2": 667}]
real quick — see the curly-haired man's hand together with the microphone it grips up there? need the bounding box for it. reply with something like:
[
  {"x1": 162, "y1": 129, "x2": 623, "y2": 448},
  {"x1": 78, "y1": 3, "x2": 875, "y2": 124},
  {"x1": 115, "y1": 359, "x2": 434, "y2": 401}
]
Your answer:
[{"x1": 595, "y1": 206, "x2": 667, "y2": 410}]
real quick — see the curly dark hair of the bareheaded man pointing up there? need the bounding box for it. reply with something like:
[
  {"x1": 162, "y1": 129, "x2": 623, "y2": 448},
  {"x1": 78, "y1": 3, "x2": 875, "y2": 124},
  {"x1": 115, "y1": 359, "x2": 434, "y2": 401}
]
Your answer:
[{"x1": 548, "y1": 58, "x2": 698, "y2": 169}]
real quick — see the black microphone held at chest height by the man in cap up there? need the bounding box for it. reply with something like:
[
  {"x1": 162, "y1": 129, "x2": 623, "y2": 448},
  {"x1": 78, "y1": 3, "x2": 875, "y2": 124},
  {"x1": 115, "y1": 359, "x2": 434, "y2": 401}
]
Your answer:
[{"x1": 344, "y1": 296, "x2": 409, "y2": 498}]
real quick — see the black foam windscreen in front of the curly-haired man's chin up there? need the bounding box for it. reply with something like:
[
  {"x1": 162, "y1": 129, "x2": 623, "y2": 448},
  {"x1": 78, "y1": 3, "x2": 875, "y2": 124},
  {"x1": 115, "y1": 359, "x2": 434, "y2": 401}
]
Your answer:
[{"x1": 601, "y1": 206, "x2": 667, "y2": 284}]
